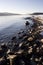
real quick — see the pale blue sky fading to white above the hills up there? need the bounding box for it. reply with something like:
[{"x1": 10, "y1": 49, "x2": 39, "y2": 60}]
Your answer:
[{"x1": 0, "y1": 0, "x2": 43, "y2": 13}]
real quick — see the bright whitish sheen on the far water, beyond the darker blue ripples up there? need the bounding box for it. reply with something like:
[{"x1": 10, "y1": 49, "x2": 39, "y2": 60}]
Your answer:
[{"x1": 0, "y1": 15, "x2": 30, "y2": 30}]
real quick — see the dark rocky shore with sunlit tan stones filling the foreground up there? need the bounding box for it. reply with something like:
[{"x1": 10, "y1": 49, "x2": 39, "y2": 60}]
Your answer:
[{"x1": 0, "y1": 18, "x2": 43, "y2": 65}]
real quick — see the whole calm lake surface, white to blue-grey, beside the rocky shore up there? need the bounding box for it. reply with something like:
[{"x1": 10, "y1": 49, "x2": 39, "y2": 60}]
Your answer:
[{"x1": 0, "y1": 15, "x2": 32, "y2": 42}]
